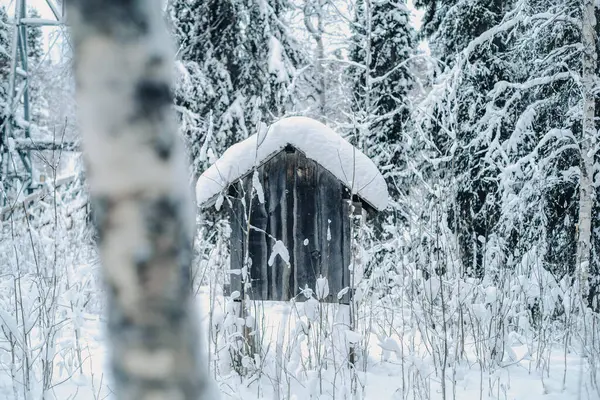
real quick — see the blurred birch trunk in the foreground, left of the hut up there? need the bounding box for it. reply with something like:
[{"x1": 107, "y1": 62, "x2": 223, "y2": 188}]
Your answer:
[{"x1": 67, "y1": 0, "x2": 216, "y2": 400}]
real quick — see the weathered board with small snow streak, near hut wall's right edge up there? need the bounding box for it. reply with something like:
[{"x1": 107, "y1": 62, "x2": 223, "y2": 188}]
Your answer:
[{"x1": 316, "y1": 168, "x2": 345, "y2": 302}]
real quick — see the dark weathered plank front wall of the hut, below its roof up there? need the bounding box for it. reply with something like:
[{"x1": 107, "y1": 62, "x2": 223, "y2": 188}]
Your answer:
[{"x1": 229, "y1": 149, "x2": 351, "y2": 302}]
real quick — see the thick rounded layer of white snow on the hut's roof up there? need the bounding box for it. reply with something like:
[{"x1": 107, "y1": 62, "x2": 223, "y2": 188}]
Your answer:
[{"x1": 196, "y1": 117, "x2": 388, "y2": 211}]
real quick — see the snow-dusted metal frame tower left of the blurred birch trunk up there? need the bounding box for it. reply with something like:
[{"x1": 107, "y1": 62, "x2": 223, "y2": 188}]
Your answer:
[{"x1": 0, "y1": 0, "x2": 78, "y2": 198}]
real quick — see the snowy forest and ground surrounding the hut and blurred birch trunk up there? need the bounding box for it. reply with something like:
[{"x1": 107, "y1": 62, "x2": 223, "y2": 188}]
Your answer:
[{"x1": 0, "y1": 0, "x2": 600, "y2": 400}]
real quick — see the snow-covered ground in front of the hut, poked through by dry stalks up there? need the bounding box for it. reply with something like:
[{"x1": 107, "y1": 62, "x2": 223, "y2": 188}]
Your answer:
[{"x1": 35, "y1": 288, "x2": 600, "y2": 400}]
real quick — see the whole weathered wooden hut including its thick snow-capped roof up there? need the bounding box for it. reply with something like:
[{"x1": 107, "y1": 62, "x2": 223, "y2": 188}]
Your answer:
[{"x1": 197, "y1": 117, "x2": 388, "y2": 303}]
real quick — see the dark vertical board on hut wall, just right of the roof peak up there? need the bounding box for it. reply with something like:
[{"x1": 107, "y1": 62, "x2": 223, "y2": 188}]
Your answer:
[{"x1": 293, "y1": 152, "x2": 321, "y2": 292}]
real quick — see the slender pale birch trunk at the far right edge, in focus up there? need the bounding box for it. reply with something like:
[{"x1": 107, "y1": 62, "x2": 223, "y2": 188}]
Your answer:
[{"x1": 576, "y1": 0, "x2": 598, "y2": 298}]
